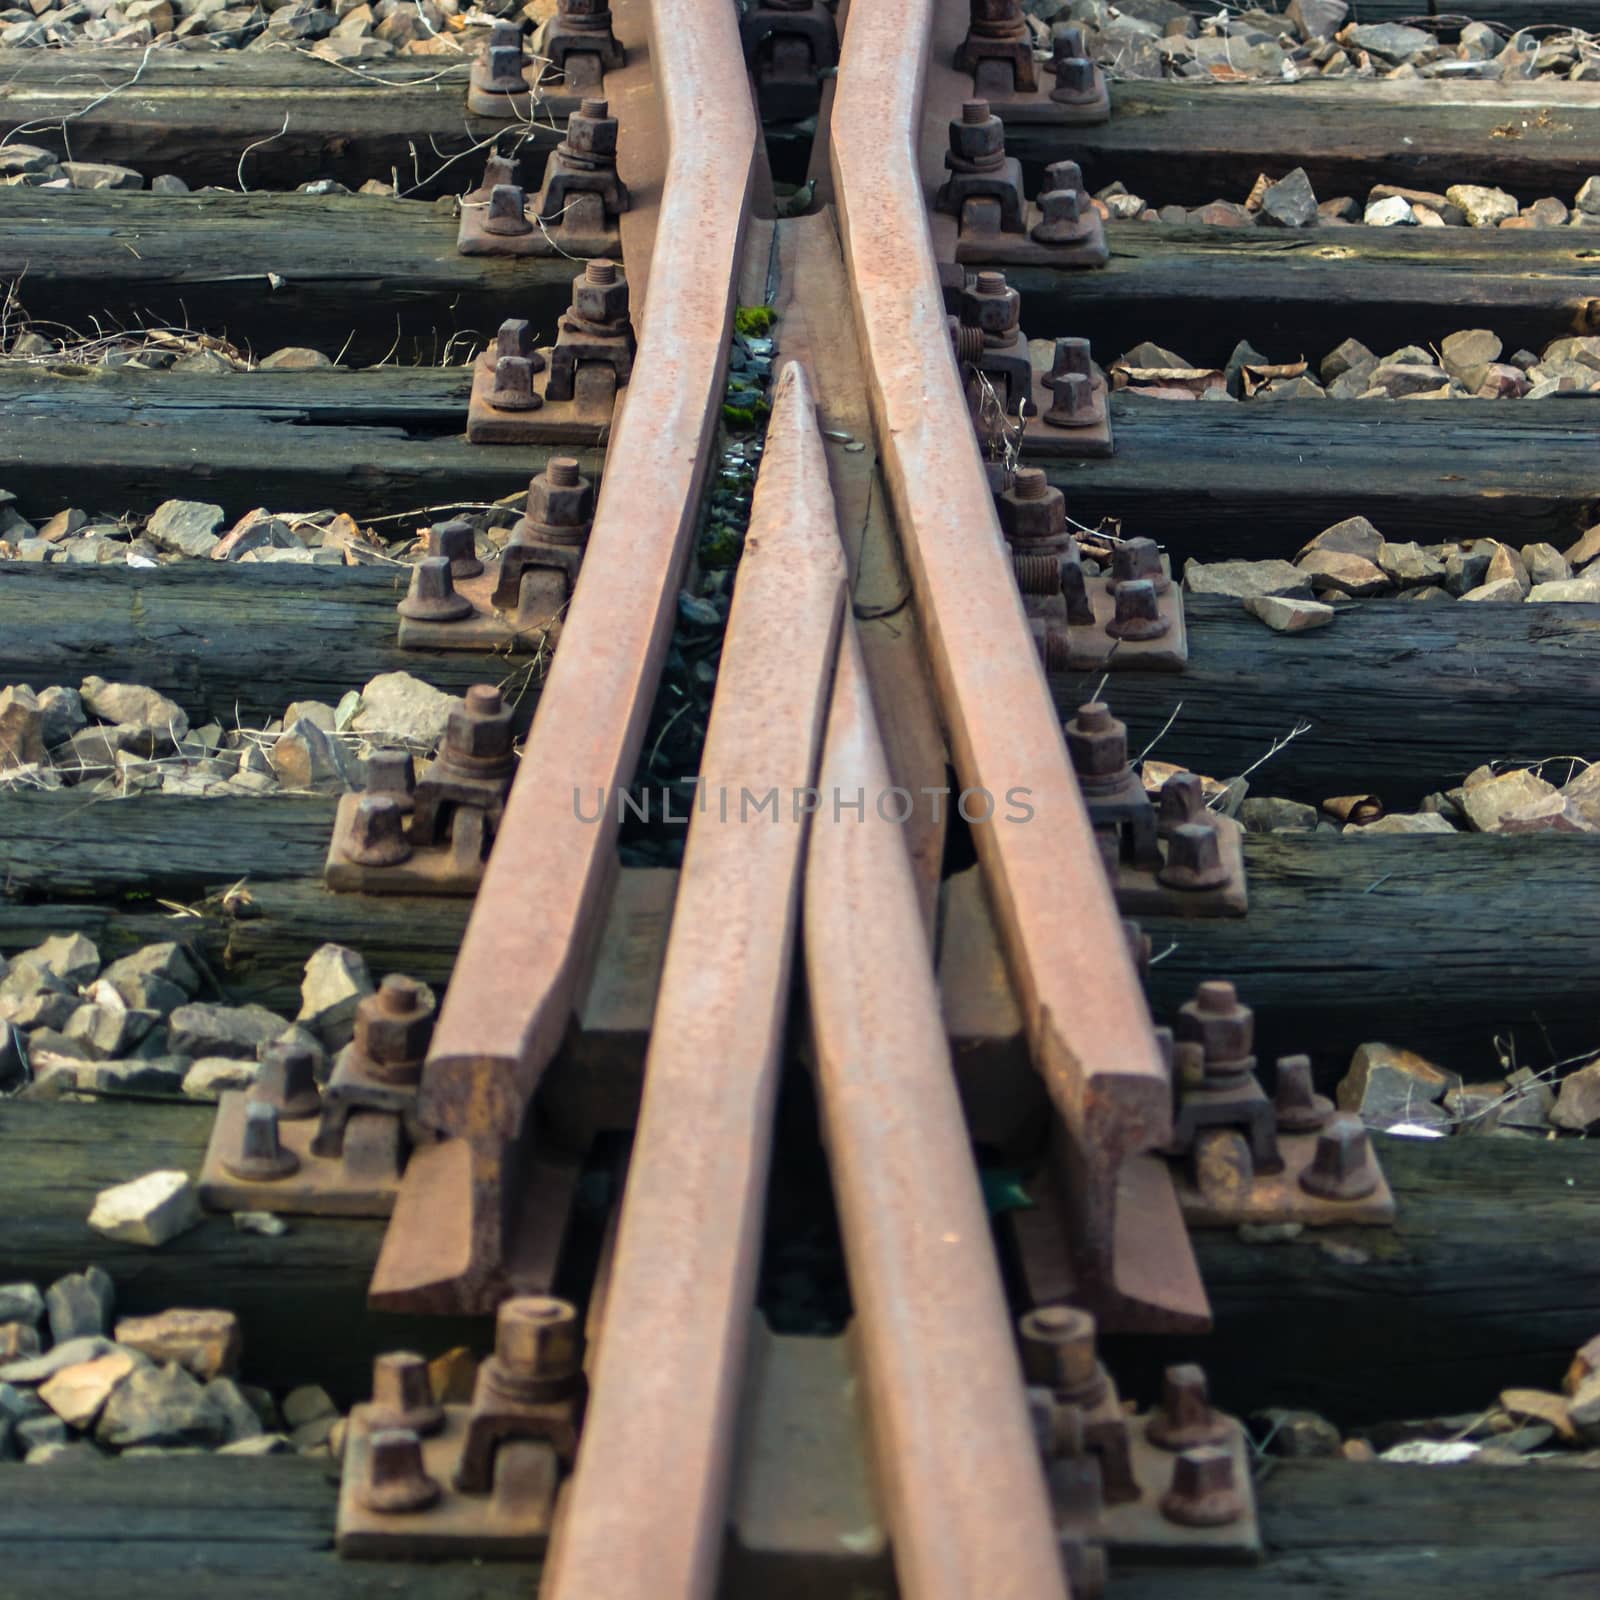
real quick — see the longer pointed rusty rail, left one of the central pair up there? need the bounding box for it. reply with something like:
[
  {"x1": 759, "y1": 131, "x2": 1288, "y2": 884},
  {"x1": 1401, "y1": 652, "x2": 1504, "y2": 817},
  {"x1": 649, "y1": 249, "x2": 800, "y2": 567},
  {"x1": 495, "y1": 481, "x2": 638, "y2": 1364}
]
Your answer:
[{"x1": 544, "y1": 365, "x2": 845, "y2": 1600}]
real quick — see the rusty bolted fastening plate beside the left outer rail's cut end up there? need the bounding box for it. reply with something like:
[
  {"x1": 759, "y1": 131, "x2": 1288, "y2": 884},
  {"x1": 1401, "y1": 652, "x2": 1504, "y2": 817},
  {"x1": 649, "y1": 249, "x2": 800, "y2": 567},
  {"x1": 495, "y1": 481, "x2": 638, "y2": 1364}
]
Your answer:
[{"x1": 200, "y1": 973, "x2": 435, "y2": 1216}]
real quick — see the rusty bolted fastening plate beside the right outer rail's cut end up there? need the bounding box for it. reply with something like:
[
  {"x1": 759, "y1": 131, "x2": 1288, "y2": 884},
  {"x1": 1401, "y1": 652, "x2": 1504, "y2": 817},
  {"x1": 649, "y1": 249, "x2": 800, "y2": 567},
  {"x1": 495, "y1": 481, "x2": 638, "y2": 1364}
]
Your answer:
[{"x1": 1166, "y1": 982, "x2": 1395, "y2": 1227}]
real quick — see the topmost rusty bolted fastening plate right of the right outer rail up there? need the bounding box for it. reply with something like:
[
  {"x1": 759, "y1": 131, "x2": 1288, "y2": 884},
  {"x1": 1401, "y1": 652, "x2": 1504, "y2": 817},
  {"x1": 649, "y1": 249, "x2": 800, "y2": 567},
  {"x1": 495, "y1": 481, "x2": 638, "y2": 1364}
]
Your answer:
[{"x1": 950, "y1": 0, "x2": 1110, "y2": 126}]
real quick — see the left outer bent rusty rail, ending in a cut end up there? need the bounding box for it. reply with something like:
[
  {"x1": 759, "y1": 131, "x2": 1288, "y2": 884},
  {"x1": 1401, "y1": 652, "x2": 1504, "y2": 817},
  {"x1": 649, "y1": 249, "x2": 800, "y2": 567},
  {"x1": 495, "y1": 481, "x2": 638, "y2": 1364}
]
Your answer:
[{"x1": 371, "y1": 0, "x2": 757, "y2": 1310}]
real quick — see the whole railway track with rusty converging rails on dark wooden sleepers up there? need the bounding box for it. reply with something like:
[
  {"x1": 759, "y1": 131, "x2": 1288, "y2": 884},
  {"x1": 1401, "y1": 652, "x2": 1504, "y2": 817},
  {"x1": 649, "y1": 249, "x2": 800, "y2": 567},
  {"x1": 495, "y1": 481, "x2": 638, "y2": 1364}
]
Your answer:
[{"x1": 0, "y1": 0, "x2": 1600, "y2": 1600}]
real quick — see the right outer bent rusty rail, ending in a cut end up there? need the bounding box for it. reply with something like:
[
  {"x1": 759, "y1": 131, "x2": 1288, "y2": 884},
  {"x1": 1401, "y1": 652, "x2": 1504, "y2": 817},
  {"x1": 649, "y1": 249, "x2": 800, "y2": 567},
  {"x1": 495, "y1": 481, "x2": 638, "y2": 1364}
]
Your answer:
[{"x1": 832, "y1": 0, "x2": 1171, "y2": 1312}]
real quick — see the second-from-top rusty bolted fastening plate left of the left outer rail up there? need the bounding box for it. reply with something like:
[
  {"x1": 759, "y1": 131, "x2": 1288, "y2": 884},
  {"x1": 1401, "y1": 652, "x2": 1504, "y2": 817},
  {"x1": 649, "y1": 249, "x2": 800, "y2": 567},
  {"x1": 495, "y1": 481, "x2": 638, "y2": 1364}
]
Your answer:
[{"x1": 456, "y1": 99, "x2": 632, "y2": 259}]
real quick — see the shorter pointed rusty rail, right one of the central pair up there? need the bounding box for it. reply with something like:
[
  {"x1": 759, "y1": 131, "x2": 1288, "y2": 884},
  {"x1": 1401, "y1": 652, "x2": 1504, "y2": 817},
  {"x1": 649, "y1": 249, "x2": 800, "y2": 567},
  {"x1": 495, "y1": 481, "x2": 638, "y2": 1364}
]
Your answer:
[{"x1": 805, "y1": 622, "x2": 1067, "y2": 1600}]
